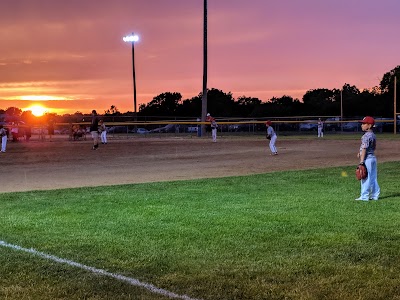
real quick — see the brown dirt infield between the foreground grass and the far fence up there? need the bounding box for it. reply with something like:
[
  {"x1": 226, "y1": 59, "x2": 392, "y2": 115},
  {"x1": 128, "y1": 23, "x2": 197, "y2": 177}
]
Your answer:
[{"x1": 0, "y1": 136, "x2": 400, "y2": 193}]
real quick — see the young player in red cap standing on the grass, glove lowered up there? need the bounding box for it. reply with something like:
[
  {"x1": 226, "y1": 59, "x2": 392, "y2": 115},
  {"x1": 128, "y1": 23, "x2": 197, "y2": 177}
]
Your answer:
[{"x1": 356, "y1": 117, "x2": 380, "y2": 201}]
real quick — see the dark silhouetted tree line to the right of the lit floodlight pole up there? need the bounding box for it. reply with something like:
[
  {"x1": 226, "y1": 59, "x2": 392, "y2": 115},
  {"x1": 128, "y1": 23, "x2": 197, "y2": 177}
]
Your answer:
[{"x1": 138, "y1": 66, "x2": 400, "y2": 118}]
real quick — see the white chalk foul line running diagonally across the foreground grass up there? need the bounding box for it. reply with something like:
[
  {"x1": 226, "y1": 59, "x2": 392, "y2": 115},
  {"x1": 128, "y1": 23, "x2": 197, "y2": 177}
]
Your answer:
[{"x1": 0, "y1": 240, "x2": 200, "y2": 300}]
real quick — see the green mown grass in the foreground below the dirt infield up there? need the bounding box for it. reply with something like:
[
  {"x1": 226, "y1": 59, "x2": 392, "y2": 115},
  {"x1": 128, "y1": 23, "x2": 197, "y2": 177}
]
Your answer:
[{"x1": 0, "y1": 162, "x2": 400, "y2": 300}]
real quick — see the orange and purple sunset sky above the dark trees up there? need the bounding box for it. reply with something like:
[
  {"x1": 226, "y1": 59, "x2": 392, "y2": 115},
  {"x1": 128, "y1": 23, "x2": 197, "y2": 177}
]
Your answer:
[{"x1": 0, "y1": 0, "x2": 400, "y2": 114}]
